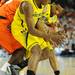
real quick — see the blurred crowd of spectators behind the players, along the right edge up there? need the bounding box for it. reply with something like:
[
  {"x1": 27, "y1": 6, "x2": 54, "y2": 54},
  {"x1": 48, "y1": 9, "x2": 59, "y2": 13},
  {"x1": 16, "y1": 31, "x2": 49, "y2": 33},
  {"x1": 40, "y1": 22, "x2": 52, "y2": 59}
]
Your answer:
[{"x1": 56, "y1": 0, "x2": 75, "y2": 56}]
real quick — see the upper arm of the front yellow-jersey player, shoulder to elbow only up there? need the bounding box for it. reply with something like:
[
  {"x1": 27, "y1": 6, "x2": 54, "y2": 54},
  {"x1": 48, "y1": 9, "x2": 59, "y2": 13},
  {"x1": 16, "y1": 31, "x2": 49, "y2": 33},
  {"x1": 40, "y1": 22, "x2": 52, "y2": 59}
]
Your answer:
[{"x1": 22, "y1": 2, "x2": 35, "y2": 32}]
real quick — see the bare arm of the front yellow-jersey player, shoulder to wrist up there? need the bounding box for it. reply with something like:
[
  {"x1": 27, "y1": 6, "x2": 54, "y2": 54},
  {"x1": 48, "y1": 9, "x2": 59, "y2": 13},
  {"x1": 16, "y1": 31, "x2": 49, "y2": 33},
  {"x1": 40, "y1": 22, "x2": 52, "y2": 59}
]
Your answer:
[{"x1": 22, "y1": 2, "x2": 47, "y2": 38}]
